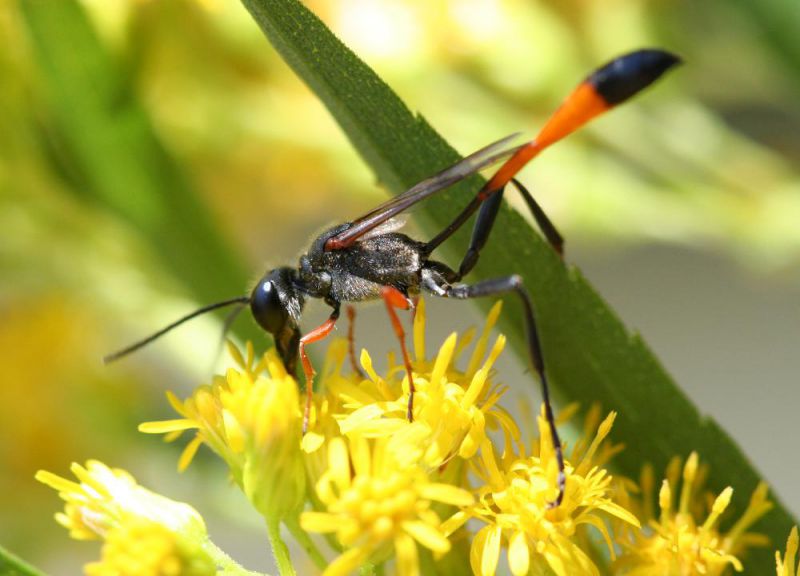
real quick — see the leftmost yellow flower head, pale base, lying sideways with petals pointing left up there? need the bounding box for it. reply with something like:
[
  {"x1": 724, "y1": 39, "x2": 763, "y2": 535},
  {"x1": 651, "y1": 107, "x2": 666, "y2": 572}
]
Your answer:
[{"x1": 36, "y1": 460, "x2": 208, "y2": 541}]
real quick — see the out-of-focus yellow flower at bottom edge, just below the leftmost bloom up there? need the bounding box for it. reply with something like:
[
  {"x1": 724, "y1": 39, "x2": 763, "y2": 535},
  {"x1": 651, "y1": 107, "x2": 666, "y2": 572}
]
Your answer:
[{"x1": 85, "y1": 518, "x2": 217, "y2": 576}]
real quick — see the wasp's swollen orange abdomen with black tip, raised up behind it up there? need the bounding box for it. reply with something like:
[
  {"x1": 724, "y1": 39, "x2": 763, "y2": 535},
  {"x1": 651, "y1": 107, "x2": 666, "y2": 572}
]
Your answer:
[{"x1": 484, "y1": 49, "x2": 682, "y2": 192}]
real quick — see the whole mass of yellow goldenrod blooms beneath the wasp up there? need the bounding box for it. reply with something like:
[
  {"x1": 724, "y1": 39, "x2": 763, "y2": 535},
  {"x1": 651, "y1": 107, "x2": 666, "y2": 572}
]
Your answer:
[{"x1": 37, "y1": 302, "x2": 784, "y2": 576}]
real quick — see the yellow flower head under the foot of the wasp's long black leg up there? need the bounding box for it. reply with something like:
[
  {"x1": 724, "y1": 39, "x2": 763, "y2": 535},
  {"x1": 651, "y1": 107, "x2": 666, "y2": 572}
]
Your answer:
[{"x1": 445, "y1": 412, "x2": 639, "y2": 576}]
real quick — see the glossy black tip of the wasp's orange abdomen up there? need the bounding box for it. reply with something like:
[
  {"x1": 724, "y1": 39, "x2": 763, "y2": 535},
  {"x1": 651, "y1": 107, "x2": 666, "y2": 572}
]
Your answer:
[{"x1": 586, "y1": 49, "x2": 683, "y2": 106}]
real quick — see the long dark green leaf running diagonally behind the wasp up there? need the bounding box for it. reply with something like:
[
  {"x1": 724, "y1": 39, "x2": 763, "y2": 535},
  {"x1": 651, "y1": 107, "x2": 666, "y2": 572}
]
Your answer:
[{"x1": 243, "y1": 0, "x2": 793, "y2": 574}]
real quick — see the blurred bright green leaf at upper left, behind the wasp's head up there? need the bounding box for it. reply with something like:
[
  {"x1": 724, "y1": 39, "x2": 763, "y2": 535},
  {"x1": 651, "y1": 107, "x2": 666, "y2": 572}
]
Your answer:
[{"x1": 20, "y1": 0, "x2": 263, "y2": 338}]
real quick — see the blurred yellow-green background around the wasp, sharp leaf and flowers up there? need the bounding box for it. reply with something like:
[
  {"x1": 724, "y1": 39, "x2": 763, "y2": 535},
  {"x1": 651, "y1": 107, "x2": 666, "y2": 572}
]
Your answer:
[{"x1": 0, "y1": 0, "x2": 800, "y2": 574}]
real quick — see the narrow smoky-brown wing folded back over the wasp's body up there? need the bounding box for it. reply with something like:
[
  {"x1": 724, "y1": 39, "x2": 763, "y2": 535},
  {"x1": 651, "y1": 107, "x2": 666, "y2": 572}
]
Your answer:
[{"x1": 325, "y1": 132, "x2": 521, "y2": 251}]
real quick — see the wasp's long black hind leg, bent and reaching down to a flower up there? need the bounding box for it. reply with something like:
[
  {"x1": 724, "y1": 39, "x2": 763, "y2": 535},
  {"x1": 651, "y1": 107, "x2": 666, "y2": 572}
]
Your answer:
[{"x1": 423, "y1": 269, "x2": 566, "y2": 507}]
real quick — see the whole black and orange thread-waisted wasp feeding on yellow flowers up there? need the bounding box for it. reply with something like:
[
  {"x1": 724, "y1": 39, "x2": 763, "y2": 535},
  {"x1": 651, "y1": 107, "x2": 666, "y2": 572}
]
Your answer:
[{"x1": 104, "y1": 49, "x2": 681, "y2": 506}]
